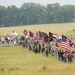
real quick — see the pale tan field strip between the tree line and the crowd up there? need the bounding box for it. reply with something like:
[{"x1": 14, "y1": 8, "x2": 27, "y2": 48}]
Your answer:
[{"x1": 0, "y1": 23, "x2": 75, "y2": 35}]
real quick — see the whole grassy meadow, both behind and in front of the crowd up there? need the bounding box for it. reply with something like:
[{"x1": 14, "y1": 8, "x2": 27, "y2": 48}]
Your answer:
[{"x1": 0, "y1": 23, "x2": 75, "y2": 75}]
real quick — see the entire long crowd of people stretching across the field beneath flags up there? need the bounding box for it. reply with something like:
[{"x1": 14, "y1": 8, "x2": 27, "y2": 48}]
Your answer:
[{"x1": 0, "y1": 35, "x2": 75, "y2": 63}]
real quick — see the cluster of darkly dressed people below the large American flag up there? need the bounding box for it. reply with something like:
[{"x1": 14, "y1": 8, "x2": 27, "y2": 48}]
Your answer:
[{"x1": 58, "y1": 50, "x2": 75, "y2": 63}]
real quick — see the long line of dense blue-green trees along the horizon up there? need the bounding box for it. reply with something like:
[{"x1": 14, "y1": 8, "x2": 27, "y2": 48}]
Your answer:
[{"x1": 0, "y1": 3, "x2": 75, "y2": 27}]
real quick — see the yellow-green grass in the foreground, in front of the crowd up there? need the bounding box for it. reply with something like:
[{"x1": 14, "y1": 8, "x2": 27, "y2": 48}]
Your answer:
[{"x1": 0, "y1": 46, "x2": 75, "y2": 75}]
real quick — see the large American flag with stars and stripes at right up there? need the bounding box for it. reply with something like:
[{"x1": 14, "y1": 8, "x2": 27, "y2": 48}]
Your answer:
[{"x1": 61, "y1": 35, "x2": 73, "y2": 51}]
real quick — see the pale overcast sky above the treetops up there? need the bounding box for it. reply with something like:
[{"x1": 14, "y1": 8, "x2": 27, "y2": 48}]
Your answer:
[{"x1": 0, "y1": 0, "x2": 75, "y2": 7}]
